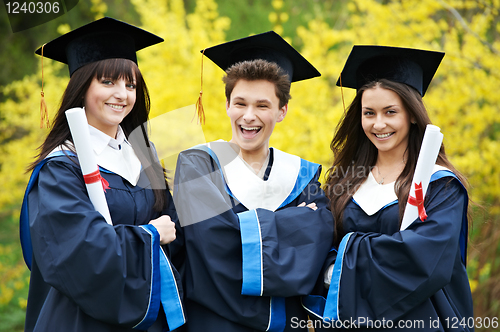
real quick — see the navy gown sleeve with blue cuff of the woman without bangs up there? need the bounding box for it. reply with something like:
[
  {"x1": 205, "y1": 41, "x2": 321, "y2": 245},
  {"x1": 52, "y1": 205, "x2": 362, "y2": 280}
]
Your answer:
[{"x1": 325, "y1": 178, "x2": 470, "y2": 321}]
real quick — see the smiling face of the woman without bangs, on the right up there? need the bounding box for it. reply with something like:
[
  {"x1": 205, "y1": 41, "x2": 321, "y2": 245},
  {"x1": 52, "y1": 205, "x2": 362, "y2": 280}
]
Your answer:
[{"x1": 361, "y1": 86, "x2": 411, "y2": 159}]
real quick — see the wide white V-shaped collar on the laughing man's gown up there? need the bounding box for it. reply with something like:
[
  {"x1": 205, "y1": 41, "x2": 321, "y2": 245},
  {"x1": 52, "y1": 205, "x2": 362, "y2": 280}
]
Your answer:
[{"x1": 208, "y1": 141, "x2": 301, "y2": 211}]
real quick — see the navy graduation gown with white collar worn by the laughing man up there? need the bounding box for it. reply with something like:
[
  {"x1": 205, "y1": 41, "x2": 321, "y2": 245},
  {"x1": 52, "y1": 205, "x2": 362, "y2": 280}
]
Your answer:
[{"x1": 171, "y1": 142, "x2": 333, "y2": 332}]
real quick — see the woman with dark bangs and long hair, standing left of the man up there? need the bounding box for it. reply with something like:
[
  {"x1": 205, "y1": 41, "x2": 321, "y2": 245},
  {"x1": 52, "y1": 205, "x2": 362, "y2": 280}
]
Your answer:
[{"x1": 21, "y1": 18, "x2": 184, "y2": 331}]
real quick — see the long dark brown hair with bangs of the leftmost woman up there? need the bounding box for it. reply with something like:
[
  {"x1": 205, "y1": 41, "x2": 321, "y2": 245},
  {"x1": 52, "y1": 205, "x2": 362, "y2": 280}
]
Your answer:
[{"x1": 28, "y1": 59, "x2": 168, "y2": 211}]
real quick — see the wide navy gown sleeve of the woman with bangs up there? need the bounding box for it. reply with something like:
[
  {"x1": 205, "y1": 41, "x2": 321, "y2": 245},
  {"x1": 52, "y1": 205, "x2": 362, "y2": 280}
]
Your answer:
[{"x1": 29, "y1": 161, "x2": 159, "y2": 327}]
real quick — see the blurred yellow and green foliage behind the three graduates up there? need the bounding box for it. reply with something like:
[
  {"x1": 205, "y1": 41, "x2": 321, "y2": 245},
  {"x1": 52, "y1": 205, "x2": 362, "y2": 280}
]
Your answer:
[{"x1": 0, "y1": 0, "x2": 500, "y2": 331}]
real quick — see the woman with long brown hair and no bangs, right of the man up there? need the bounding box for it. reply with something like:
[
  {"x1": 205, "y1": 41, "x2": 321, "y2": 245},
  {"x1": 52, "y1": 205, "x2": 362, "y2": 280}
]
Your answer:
[{"x1": 312, "y1": 46, "x2": 474, "y2": 331}]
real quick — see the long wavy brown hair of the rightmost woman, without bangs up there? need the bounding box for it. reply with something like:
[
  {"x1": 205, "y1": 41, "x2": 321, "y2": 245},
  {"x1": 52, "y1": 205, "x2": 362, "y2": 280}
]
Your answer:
[{"x1": 324, "y1": 79, "x2": 467, "y2": 246}]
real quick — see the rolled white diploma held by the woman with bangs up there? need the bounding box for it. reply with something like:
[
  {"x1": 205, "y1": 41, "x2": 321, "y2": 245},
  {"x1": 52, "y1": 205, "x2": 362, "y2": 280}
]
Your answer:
[{"x1": 66, "y1": 107, "x2": 113, "y2": 225}]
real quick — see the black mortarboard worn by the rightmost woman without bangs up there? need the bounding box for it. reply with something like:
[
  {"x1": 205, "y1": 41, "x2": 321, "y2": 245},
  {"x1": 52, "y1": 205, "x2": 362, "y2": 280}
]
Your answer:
[{"x1": 337, "y1": 45, "x2": 444, "y2": 97}]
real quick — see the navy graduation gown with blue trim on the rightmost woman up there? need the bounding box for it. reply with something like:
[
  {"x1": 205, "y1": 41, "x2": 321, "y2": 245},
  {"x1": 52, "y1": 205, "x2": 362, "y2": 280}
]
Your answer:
[{"x1": 305, "y1": 166, "x2": 474, "y2": 331}]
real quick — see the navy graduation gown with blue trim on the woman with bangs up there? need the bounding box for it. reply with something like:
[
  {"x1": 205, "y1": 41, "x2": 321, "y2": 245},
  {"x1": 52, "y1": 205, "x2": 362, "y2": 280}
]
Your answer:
[{"x1": 21, "y1": 151, "x2": 183, "y2": 332}]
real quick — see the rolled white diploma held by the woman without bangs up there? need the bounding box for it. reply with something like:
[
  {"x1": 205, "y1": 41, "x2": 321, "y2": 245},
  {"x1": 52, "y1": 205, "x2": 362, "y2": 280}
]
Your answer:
[{"x1": 401, "y1": 125, "x2": 443, "y2": 230}]
